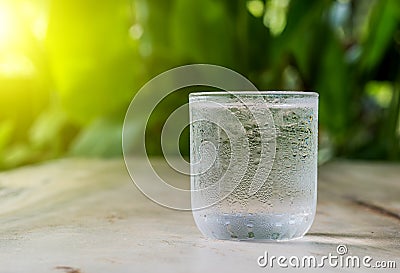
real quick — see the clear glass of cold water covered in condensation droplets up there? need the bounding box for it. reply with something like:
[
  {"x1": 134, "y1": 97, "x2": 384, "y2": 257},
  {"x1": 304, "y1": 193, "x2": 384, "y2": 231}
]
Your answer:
[{"x1": 189, "y1": 91, "x2": 318, "y2": 241}]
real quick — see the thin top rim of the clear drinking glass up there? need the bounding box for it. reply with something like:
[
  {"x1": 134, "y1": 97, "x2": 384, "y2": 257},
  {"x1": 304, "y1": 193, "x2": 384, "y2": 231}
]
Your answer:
[{"x1": 189, "y1": 91, "x2": 319, "y2": 97}]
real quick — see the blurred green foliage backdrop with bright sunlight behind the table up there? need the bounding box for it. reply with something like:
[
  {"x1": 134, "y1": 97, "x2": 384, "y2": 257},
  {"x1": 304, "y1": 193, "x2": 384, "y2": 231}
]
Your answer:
[{"x1": 0, "y1": 0, "x2": 400, "y2": 169}]
